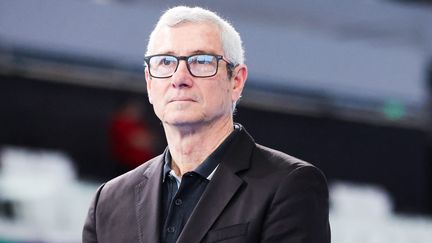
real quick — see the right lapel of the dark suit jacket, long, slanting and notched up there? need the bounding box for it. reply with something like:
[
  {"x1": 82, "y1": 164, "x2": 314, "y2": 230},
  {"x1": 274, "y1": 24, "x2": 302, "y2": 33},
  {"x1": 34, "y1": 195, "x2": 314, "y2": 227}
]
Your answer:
[{"x1": 177, "y1": 128, "x2": 254, "y2": 243}]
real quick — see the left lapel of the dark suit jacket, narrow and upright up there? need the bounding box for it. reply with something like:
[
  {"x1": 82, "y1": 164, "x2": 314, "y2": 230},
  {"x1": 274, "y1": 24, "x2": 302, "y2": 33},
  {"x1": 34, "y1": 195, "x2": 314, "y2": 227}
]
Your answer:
[{"x1": 135, "y1": 155, "x2": 163, "y2": 243}]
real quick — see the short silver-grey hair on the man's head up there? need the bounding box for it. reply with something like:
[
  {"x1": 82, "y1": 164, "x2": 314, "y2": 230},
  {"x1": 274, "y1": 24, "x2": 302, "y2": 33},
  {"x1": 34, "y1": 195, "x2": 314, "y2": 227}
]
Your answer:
[{"x1": 146, "y1": 6, "x2": 244, "y2": 65}]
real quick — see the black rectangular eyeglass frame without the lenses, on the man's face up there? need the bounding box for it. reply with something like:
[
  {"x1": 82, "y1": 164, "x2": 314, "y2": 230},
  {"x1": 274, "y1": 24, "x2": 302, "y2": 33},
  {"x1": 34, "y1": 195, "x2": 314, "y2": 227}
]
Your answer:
[{"x1": 144, "y1": 53, "x2": 238, "y2": 78}]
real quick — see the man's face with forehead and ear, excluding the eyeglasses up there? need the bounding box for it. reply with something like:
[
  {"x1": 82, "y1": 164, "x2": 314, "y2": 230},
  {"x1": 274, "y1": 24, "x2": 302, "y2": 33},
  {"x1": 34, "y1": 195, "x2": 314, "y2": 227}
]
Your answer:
[{"x1": 145, "y1": 23, "x2": 247, "y2": 126}]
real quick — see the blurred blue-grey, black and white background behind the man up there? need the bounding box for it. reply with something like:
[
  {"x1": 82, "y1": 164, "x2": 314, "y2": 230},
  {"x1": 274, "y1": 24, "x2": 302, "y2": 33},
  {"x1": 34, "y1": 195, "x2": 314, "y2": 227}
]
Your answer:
[{"x1": 0, "y1": 0, "x2": 432, "y2": 243}]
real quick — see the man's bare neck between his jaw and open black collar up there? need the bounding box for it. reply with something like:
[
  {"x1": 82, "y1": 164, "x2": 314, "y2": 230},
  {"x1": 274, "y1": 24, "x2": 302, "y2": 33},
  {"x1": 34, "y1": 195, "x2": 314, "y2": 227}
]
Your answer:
[{"x1": 164, "y1": 119, "x2": 234, "y2": 176}]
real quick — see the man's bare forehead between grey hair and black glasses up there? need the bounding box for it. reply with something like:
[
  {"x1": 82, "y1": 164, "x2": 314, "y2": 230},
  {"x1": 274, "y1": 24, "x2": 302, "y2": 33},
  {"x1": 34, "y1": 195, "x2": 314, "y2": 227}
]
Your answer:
[{"x1": 150, "y1": 23, "x2": 224, "y2": 55}]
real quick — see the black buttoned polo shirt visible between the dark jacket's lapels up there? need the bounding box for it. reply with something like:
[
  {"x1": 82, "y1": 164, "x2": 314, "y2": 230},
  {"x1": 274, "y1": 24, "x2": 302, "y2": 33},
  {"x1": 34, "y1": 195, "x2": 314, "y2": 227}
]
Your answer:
[{"x1": 160, "y1": 126, "x2": 240, "y2": 243}]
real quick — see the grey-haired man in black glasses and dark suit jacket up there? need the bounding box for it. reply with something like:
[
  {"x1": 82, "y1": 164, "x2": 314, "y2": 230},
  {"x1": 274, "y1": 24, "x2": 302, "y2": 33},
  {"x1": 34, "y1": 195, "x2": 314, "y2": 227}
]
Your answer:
[{"x1": 83, "y1": 7, "x2": 330, "y2": 243}]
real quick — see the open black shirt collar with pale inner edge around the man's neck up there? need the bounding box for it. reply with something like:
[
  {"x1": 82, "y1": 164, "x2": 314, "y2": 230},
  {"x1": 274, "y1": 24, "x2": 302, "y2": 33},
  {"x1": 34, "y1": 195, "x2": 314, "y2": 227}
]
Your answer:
[{"x1": 162, "y1": 124, "x2": 241, "y2": 183}]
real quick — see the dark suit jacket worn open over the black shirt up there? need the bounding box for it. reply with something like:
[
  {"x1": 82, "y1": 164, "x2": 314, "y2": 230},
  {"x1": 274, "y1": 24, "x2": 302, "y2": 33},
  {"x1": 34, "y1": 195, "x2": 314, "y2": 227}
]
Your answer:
[{"x1": 83, "y1": 128, "x2": 330, "y2": 243}]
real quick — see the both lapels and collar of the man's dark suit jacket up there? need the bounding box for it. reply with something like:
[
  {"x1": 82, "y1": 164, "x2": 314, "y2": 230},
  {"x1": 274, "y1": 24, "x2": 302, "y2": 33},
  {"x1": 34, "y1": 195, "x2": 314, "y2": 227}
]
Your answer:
[{"x1": 135, "y1": 125, "x2": 255, "y2": 243}]
